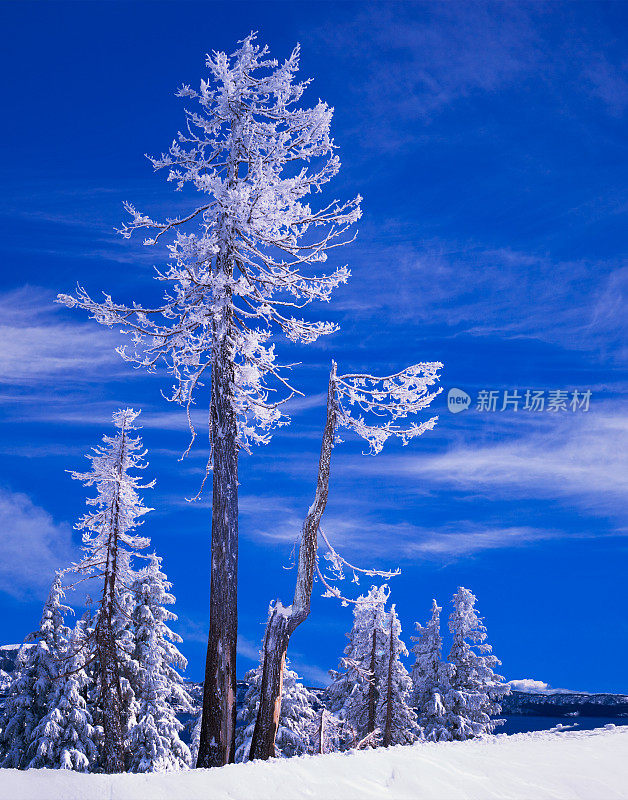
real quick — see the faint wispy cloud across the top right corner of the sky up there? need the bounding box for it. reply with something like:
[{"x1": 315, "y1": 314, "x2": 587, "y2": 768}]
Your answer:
[{"x1": 319, "y1": 2, "x2": 628, "y2": 153}]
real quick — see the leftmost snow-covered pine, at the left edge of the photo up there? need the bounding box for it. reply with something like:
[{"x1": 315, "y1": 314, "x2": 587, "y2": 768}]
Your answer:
[{"x1": 0, "y1": 573, "x2": 70, "y2": 769}]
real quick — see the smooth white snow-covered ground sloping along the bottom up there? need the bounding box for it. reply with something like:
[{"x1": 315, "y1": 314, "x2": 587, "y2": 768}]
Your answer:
[{"x1": 0, "y1": 726, "x2": 628, "y2": 800}]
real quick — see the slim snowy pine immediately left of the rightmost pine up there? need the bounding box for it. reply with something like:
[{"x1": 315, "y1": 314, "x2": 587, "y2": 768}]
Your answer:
[{"x1": 411, "y1": 600, "x2": 451, "y2": 742}]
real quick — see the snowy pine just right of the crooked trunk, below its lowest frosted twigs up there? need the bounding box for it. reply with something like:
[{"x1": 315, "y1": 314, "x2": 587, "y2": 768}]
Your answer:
[{"x1": 327, "y1": 586, "x2": 390, "y2": 739}]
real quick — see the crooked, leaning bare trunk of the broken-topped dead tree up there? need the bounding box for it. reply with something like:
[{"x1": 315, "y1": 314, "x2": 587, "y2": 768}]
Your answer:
[{"x1": 249, "y1": 364, "x2": 336, "y2": 760}]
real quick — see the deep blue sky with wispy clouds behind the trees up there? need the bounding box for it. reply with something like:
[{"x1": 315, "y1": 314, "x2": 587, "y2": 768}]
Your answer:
[{"x1": 0, "y1": 2, "x2": 628, "y2": 691}]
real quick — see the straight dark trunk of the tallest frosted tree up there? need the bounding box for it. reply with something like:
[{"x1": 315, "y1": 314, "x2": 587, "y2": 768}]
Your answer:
[{"x1": 196, "y1": 236, "x2": 238, "y2": 767}]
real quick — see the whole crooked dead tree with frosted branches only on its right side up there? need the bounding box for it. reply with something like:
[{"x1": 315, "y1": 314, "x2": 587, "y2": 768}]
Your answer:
[{"x1": 250, "y1": 362, "x2": 442, "y2": 759}]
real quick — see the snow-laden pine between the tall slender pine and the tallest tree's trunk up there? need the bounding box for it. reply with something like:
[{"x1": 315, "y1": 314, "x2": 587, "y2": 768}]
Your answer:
[{"x1": 128, "y1": 554, "x2": 194, "y2": 772}]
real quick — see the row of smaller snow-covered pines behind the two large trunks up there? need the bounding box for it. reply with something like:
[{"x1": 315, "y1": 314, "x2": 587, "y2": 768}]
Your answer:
[{"x1": 0, "y1": 409, "x2": 507, "y2": 772}]
